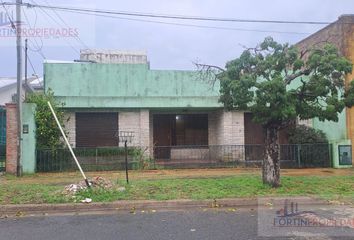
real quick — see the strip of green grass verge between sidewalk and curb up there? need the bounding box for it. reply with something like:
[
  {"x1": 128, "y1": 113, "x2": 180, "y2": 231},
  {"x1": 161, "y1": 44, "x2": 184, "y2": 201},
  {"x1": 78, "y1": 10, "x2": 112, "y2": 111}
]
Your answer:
[{"x1": 0, "y1": 175, "x2": 354, "y2": 204}]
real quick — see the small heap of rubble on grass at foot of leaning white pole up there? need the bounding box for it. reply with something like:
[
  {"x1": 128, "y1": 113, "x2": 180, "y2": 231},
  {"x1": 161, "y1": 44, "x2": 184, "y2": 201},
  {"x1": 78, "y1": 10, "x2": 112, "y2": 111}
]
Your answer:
[{"x1": 63, "y1": 176, "x2": 113, "y2": 195}]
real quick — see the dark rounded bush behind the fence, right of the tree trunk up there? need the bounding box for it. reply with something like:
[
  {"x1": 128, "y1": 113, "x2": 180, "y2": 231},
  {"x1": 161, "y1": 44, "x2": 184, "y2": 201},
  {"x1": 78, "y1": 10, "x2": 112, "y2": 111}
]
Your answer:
[{"x1": 288, "y1": 125, "x2": 328, "y2": 144}]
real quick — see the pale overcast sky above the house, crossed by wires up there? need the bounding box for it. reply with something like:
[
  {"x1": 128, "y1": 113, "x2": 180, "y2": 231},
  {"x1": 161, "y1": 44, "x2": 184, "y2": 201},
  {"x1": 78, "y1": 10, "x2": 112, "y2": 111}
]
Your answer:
[{"x1": 0, "y1": 0, "x2": 354, "y2": 77}]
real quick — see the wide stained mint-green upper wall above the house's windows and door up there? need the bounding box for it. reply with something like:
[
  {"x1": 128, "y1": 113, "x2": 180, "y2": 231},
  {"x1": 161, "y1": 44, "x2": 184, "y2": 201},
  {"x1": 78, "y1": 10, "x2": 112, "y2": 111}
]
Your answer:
[{"x1": 44, "y1": 63, "x2": 222, "y2": 108}]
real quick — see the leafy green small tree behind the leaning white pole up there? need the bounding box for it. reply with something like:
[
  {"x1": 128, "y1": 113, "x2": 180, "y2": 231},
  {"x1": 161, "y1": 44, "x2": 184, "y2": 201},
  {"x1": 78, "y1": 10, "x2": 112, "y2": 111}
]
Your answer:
[{"x1": 26, "y1": 89, "x2": 64, "y2": 149}]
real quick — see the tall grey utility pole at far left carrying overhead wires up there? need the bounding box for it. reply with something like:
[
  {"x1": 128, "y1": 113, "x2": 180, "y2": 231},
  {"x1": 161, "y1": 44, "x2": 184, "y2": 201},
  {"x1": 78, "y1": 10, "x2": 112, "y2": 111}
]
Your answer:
[{"x1": 16, "y1": 0, "x2": 22, "y2": 177}]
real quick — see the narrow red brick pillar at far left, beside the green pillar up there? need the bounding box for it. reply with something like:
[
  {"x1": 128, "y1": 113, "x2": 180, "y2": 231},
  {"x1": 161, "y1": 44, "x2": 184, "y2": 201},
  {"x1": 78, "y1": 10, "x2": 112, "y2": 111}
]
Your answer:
[{"x1": 6, "y1": 103, "x2": 18, "y2": 174}]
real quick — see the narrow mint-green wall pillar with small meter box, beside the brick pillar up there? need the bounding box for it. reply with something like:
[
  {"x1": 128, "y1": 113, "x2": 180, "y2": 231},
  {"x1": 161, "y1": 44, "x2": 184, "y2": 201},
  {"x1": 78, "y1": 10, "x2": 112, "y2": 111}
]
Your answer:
[{"x1": 21, "y1": 103, "x2": 36, "y2": 173}]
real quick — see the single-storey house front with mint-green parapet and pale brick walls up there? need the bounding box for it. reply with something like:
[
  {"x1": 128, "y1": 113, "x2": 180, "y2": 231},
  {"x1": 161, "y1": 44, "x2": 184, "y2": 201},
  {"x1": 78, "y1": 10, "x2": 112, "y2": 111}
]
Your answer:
[{"x1": 44, "y1": 51, "x2": 252, "y2": 164}]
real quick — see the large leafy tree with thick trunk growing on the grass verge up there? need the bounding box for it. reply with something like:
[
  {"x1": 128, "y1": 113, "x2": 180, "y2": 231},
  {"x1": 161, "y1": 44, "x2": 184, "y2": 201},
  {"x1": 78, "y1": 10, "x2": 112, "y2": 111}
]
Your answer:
[{"x1": 204, "y1": 37, "x2": 354, "y2": 187}]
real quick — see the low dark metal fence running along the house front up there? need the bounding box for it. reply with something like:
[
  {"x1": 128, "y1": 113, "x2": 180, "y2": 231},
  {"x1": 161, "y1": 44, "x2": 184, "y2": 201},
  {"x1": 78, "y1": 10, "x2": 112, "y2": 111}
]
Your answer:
[{"x1": 37, "y1": 144, "x2": 331, "y2": 172}]
